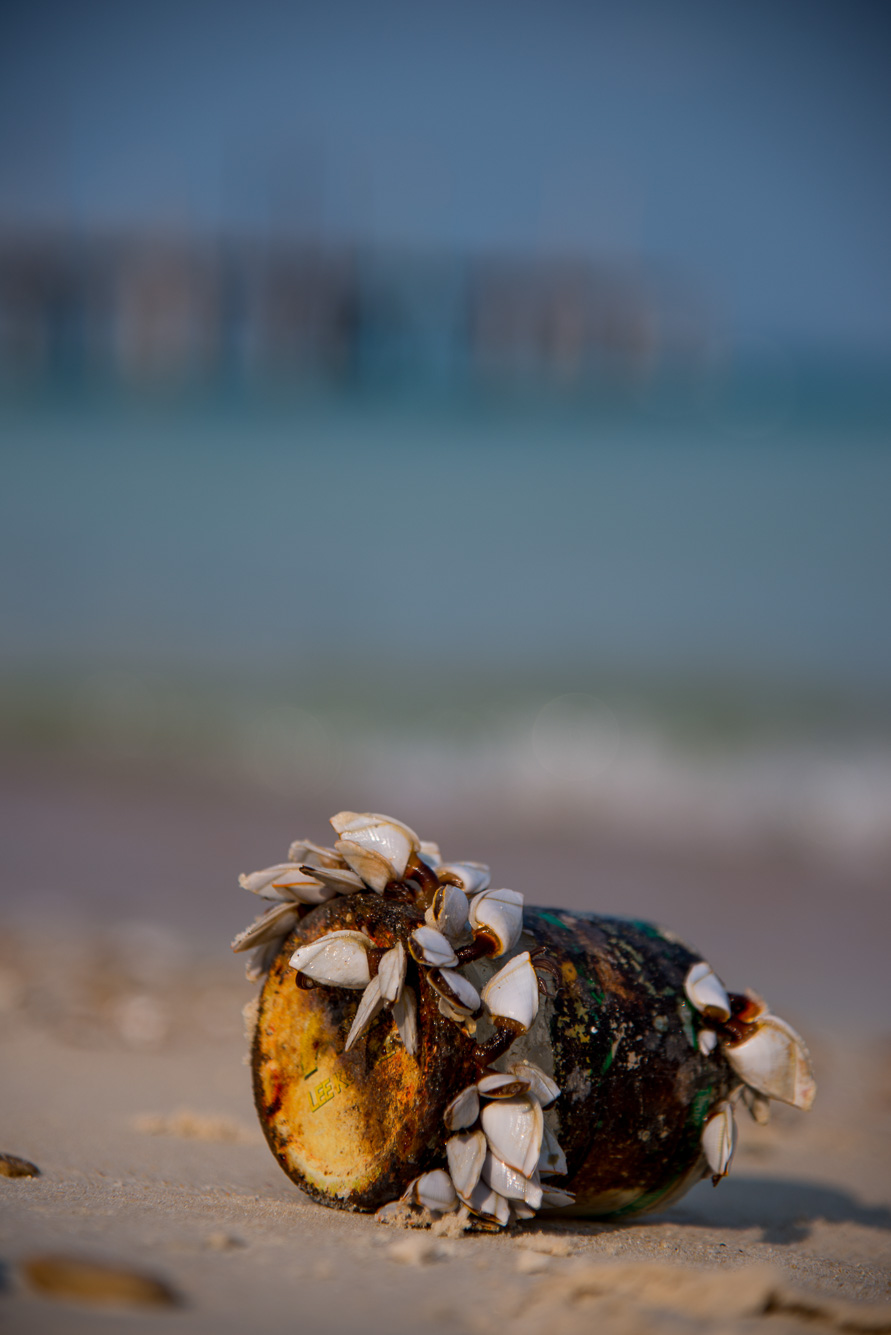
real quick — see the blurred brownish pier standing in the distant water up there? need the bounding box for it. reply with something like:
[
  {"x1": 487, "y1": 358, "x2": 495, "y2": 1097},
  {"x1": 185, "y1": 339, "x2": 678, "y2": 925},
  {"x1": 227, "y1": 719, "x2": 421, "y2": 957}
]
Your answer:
[{"x1": 0, "y1": 228, "x2": 713, "y2": 391}]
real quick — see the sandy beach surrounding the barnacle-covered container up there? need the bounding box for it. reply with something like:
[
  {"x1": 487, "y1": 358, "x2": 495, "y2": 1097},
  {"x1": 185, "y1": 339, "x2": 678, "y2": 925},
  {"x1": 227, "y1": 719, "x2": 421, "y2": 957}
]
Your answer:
[{"x1": 0, "y1": 758, "x2": 891, "y2": 1332}]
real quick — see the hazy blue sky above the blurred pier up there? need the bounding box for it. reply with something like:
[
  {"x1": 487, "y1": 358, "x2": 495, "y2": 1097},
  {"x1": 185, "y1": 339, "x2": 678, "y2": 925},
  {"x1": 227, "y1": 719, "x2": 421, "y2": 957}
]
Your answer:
[{"x1": 0, "y1": 0, "x2": 891, "y2": 352}]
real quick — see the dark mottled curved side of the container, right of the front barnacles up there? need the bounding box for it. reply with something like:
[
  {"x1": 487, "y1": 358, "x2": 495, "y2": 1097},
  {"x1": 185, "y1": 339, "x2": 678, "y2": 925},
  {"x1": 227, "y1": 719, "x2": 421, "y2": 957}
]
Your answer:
[{"x1": 525, "y1": 909, "x2": 739, "y2": 1215}]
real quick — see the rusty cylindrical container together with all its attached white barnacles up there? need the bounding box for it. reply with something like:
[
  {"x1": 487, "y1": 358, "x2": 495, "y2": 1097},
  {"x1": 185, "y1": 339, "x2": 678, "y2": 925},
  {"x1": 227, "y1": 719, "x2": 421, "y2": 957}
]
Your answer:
[{"x1": 232, "y1": 812, "x2": 815, "y2": 1230}]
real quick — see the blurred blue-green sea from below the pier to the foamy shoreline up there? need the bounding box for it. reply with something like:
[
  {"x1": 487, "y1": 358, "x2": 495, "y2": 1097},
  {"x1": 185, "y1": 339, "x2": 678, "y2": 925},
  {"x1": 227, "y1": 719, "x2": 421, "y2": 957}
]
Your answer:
[{"x1": 0, "y1": 384, "x2": 891, "y2": 857}]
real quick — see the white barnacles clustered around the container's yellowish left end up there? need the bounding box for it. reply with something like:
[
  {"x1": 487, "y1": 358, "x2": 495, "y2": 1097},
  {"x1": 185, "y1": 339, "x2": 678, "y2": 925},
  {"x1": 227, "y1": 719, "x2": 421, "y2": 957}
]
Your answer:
[{"x1": 232, "y1": 812, "x2": 573, "y2": 1224}]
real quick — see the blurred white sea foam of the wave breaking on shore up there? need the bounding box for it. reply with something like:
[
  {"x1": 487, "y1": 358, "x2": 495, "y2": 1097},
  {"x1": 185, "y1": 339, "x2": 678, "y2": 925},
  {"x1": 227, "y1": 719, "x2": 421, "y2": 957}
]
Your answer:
[{"x1": 349, "y1": 725, "x2": 891, "y2": 862}]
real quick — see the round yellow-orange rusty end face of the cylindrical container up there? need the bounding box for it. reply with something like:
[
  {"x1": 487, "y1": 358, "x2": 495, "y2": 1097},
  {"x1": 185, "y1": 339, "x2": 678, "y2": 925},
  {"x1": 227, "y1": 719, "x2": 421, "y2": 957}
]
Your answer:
[{"x1": 252, "y1": 894, "x2": 474, "y2": 1210}]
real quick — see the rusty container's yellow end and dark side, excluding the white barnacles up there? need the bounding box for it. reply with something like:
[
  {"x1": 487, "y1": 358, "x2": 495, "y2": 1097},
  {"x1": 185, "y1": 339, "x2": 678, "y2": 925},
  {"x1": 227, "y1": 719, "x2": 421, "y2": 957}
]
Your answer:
[{"x1": 252, "y1": 894, "x2": 739, "y2": 1215}]
